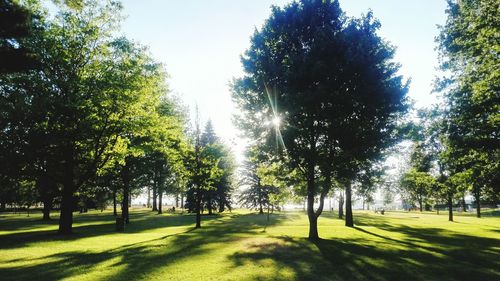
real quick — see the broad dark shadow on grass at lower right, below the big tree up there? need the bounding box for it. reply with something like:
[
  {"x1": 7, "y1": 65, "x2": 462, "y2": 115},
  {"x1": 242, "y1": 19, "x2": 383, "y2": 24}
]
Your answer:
[{"x1": 231, "y1": 223, "x2": 500, "y2": 280}]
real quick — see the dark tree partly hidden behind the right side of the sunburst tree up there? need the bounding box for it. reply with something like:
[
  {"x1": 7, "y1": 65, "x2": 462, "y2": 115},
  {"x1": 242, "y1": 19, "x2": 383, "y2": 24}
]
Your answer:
[{"x1": 336, "y1": 12, "x2": 408, "y2": 226}]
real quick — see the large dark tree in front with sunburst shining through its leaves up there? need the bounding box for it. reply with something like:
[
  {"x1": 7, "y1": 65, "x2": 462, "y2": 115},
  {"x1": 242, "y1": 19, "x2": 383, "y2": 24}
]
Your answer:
[{"x1": 233, "y1": 1, "x2": 344, "y2": 240}]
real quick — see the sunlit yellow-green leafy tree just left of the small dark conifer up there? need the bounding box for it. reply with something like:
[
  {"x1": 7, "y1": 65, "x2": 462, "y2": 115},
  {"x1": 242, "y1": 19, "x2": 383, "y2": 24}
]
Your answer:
[{"x1": 116, "y1": 60, "x2": 184, "y2": 223}]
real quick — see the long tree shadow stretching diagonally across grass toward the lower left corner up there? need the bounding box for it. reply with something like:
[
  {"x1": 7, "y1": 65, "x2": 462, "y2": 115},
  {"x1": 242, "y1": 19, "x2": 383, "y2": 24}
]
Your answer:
[{"x1": 0, "y1": 211, "x2": 285, "y2": 280}]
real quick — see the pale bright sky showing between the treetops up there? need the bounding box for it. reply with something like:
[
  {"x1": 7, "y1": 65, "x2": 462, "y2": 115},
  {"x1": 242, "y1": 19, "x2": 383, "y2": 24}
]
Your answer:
[{"x1": 122, "y1": 0, "x2": 446, "y2": 161}]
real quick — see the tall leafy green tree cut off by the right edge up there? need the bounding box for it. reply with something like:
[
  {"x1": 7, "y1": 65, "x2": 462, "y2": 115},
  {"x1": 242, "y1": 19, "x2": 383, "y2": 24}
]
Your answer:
[{"x1": 436, "y1": 0, "x2": 500, "y2": 217}]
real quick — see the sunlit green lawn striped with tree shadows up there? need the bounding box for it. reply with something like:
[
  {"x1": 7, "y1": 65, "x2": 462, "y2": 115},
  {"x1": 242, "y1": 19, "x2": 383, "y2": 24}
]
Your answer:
[{"x1": 0, "y1": 207, "x2": 500, "y2": 281}]
